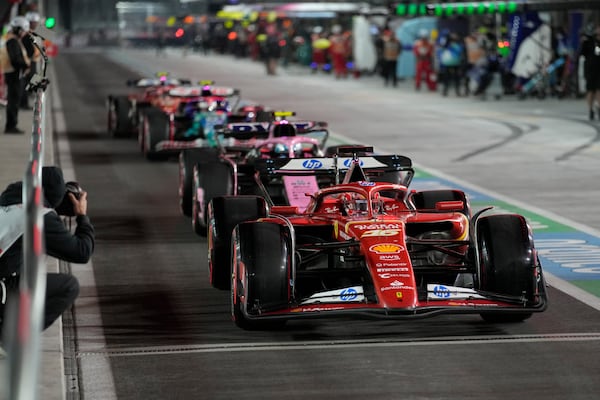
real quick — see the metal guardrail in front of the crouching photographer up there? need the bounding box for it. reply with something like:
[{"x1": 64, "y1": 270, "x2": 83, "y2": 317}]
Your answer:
[{"x1": 3, "y1": 35, "x2": 49, "y2": 400}]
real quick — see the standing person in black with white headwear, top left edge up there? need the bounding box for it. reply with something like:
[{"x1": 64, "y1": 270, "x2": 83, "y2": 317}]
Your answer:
[{"x1": 0, "y1": 17, "x2": 30, "y2": 133}]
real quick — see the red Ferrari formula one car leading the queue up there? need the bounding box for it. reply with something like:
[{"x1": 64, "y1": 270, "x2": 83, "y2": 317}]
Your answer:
[{"x1": 208, "y1": 155, "x2": 547, "y2": 329}]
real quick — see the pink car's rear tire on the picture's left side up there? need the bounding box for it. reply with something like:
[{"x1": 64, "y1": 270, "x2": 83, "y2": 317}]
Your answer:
[{"x1": 178, "y1": 147, "x2": 218, "y2": 217}]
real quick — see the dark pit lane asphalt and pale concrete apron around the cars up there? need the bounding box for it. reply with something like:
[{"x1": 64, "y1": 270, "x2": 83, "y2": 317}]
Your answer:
[{"x1": 54, "y1": 50, "x2": 600, "y2": 399}]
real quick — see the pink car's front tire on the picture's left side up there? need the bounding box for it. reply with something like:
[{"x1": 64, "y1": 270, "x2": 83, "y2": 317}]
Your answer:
[{"x1": 192, "y1": 158, "x2": 234, "y2": 236}]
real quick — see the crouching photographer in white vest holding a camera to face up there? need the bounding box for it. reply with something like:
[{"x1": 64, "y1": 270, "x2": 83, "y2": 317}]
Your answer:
[{"x1": 0, "y1": 167, "x2": 95, "y2": 330}]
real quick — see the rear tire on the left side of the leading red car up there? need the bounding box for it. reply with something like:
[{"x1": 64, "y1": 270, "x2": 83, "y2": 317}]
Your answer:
[{"x1": 207, "y1": 196, "x2": 267, "y2": 290}]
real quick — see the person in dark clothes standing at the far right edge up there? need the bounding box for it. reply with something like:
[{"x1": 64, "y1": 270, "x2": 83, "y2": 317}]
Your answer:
[{"x1": 579, "y1": 27, "x2": 600, "y2": 121}]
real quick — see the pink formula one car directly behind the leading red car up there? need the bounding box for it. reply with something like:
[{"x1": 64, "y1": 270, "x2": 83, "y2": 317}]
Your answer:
[{"x1": 179, "y1": 115, "x2": 329, "y2": 223}]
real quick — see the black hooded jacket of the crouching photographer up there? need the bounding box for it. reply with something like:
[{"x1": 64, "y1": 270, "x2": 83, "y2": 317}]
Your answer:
[{"x1": 0, "y1": 167, "x2": 95, "y2": 278}]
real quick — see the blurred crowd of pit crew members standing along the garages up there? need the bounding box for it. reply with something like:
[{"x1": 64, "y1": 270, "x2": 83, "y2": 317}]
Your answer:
[{"x1": 173, "y1": 21, "x2": 577, "y2": 105}]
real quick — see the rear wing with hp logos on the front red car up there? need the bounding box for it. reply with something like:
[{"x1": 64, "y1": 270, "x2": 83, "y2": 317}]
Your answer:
[{"x1": 254, "y1": 155, "x2": 414, "y2": 187}]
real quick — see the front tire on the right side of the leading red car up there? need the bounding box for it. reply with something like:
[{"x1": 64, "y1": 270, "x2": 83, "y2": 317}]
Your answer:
[{"x1": 476, "y1": 214, "x2": 545, "y2": 322}]
